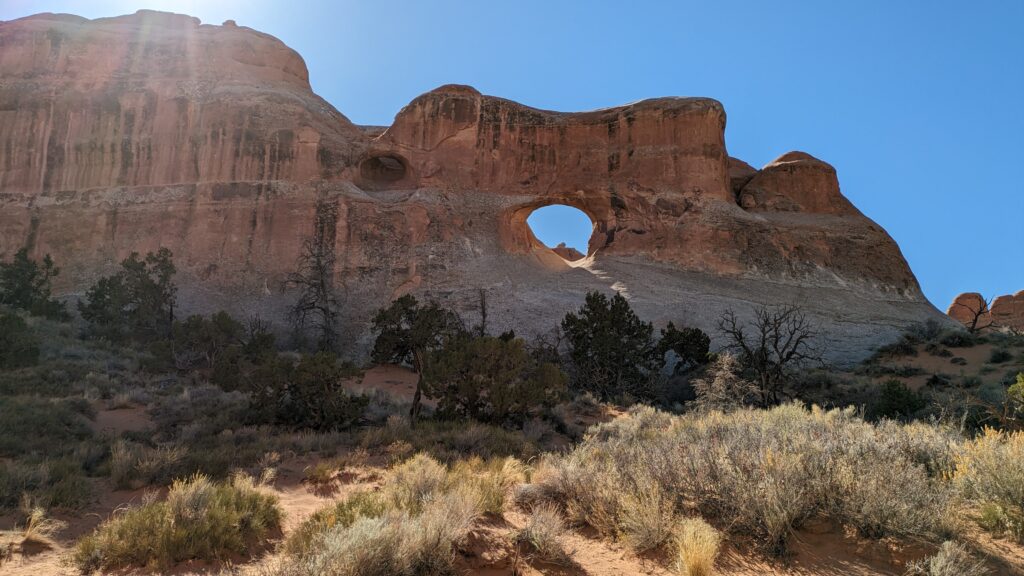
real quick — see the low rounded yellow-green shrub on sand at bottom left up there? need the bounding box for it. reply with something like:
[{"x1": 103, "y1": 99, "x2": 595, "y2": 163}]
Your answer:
[{"x1": 73, "y1": 476, "x2": 283, "y2": 573}]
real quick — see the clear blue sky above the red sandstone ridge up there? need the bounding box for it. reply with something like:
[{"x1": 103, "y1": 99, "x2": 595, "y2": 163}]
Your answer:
[{"x1": 0, "y1": 0, "x2": 1024, "y2": 310}]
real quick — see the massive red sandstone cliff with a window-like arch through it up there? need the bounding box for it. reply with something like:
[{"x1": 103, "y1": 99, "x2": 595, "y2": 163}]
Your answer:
[{"x1": 0, "y1": 11, "x2": 944, "y2": 361}]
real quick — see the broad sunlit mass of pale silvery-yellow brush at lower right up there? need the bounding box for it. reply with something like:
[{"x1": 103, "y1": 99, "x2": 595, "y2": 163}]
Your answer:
[{"x1": 531, "y1": 405, "x2": 950, "y2": 553}]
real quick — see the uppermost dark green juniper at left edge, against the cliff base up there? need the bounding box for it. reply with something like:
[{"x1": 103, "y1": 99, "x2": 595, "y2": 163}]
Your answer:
[{"x1": 0, "y1": 248, "x2": 68, "y2": 319}]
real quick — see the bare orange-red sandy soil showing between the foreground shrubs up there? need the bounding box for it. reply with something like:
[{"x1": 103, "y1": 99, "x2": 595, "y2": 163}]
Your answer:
[{"x1": 0, "y1": 364, "x2": 1024, "y2": 576}]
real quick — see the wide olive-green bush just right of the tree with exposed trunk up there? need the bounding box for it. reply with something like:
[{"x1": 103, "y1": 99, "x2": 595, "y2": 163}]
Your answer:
[{"x1": 423, "y1": 335, "x2": 566, "y2": 424}]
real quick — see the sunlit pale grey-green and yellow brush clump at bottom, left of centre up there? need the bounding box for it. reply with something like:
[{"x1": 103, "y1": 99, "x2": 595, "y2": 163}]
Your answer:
[{"x1": 272, "y1": 453, "x2": 523, "y2": 576}]
